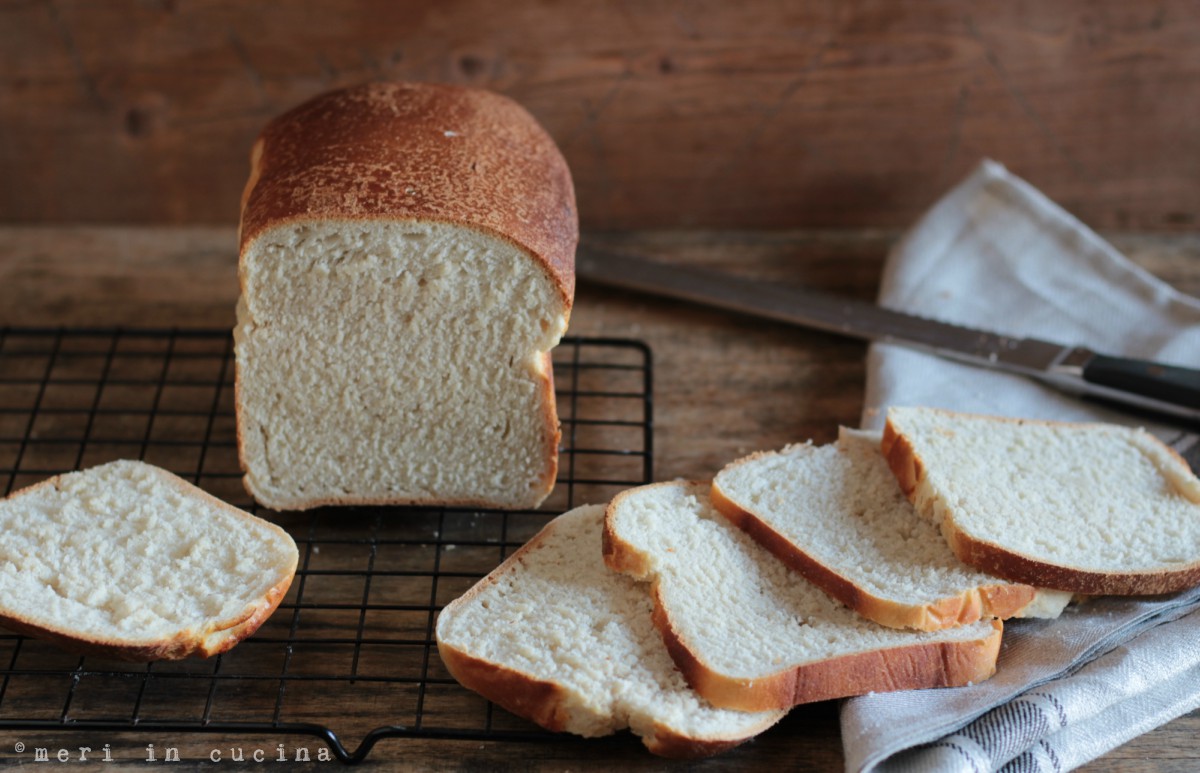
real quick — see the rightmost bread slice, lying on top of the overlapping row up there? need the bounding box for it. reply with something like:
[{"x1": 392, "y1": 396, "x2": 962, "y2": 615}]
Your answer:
[{"x1": 882, "y1": 407, "x2": 1200, "y2": 595}]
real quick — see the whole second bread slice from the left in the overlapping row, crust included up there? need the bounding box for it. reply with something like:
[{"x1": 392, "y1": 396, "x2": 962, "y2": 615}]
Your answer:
[{"x1": 605, "y1": 483, "x2": 1003, "y2": 711}]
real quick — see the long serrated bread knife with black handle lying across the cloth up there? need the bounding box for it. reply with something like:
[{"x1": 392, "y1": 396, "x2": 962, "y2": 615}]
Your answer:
[{"x1": 575, "y1": 245, "x2": 1200, "y2": 421}]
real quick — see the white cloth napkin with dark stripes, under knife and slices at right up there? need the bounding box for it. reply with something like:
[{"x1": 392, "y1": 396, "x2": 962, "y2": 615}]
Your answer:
[{"x1": 841, "y1": 162, "x2": 1200, "y2": 773}]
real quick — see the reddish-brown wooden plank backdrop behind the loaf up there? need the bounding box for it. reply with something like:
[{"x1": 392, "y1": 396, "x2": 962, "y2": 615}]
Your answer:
[{"x1": 0, "y1": 0, "x2": 1200, "y2": 230}]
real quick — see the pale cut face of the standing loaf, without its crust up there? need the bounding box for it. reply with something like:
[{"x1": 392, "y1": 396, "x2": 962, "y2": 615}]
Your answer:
[{"x1": 235, "y1": 222, "x2": 566, "y2": 508}]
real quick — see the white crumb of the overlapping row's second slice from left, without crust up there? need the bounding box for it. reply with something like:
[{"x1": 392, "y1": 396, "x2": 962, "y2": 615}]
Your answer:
[{"x1": 608, "y1": 483, "x2": 992, "y2": 681}]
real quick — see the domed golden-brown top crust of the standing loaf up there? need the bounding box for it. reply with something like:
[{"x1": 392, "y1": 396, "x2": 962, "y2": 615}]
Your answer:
[{"x1": 239, "y1": 83, "x2": 578, "y2": 304}]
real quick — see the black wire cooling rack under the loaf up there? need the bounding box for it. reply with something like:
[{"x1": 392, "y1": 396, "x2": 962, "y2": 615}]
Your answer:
[{"x1": 0, "y1": 328, "x2": 653, "y2": 762}]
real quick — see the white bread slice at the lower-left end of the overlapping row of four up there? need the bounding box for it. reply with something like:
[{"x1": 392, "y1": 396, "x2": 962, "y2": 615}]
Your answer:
[{"x1": 437, "y1": 505, "x2": 782, "y2": 756}]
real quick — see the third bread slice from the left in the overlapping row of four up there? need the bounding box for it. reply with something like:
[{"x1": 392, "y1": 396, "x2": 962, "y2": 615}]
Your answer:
[{"x1": 712, "y1": 429, "x2": 1070, "y2": 630}]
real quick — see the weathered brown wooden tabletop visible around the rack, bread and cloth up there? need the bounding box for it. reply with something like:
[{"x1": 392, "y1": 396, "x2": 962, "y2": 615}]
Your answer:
[{"x1": 0, "y1": 227, "x2": 1200, "y2": 771}]
